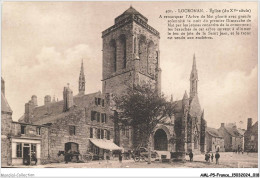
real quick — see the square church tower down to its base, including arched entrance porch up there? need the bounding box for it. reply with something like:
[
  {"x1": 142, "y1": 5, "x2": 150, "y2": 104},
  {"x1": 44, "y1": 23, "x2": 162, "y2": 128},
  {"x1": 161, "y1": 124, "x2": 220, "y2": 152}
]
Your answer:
[{"x1": 102, "y1": 7, "x2": 175, "y2": 151}]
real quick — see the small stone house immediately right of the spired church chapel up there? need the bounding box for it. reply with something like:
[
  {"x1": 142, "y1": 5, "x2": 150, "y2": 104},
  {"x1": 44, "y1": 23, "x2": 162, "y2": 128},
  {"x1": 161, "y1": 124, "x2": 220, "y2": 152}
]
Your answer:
[{"x1": 206, "y1": 127, "x2": 225, "y2": 152}]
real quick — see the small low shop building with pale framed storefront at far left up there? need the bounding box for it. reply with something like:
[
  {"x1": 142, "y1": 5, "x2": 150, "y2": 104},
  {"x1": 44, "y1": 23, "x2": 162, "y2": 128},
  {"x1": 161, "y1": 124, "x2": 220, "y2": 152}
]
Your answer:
[{"x1": 11, "y1": 121, "x2": 50, "y2": 165}]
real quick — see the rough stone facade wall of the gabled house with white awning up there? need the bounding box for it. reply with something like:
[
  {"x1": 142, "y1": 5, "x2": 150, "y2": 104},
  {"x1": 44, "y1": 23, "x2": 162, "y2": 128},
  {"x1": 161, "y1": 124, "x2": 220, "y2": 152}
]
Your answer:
[{"x1": 43, "y1": 94, "x2": 113, "y2": 162}]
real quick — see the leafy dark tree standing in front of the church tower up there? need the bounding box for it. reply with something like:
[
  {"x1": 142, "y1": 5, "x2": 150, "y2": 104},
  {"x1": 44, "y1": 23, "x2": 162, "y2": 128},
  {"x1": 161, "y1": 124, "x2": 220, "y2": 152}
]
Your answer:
[{"x1": 114, "y1": 83, "x2": 174, "y2": 164}]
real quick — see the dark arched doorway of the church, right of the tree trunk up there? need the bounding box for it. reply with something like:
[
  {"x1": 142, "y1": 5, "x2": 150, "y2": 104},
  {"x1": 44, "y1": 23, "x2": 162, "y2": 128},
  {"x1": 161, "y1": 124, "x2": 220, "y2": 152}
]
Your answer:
[{"x1": 154, "y1": 129, "x2": 168, "y2": 151}]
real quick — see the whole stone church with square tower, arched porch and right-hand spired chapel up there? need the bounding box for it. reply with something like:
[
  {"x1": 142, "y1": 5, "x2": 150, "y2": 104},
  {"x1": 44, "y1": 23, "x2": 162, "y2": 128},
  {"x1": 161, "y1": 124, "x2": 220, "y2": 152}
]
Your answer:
[{"x1": 102, "y1": 7, "x2": 206, "y2": 152}]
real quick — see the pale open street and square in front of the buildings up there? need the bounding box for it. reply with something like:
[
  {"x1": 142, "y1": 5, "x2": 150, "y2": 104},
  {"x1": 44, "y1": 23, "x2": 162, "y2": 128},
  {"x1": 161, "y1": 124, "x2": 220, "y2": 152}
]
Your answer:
[{"x1": 8, "y1": 152, "x2": 258, "y2": 168}]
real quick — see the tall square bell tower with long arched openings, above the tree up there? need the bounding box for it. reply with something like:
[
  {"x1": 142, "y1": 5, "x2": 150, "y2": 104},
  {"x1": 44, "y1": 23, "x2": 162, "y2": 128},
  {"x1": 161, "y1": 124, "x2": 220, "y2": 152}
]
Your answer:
[{"x1": 102, "y1": 6, "x2": 161, "y2": 95}]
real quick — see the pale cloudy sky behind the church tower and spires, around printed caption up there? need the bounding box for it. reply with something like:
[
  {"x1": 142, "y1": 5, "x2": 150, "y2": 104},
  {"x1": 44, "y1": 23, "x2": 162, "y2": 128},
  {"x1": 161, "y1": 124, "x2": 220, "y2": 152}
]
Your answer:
[{"x1": 1, "y1": 2, "x2": 258, "y2": 128}]
